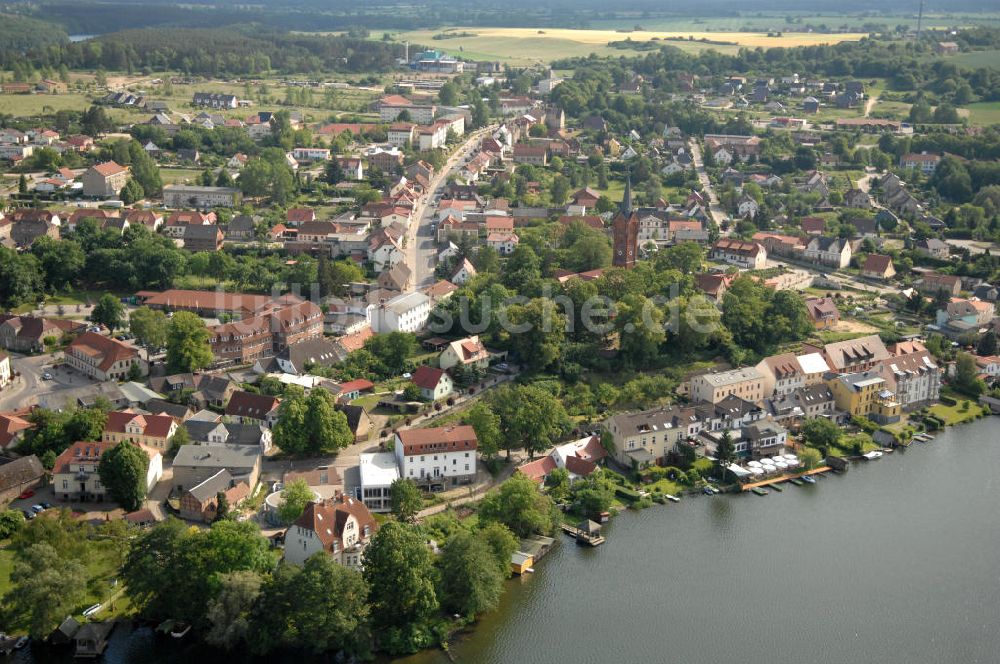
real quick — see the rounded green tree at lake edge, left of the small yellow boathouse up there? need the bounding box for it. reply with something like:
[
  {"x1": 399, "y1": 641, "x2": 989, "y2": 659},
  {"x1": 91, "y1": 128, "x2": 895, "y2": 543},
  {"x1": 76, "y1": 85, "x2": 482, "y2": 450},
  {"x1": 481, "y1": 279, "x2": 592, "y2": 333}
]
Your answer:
[{"x1": 437, "y1": 531, "x2": 504, "y2": 616}]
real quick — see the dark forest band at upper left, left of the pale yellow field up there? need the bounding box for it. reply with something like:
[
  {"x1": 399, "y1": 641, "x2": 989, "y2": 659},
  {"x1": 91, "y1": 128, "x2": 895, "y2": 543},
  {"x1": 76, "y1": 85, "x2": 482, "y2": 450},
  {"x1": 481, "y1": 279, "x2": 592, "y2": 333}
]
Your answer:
[{"x1": 0, "y1": 26, "x2": 403, "y2": 76}]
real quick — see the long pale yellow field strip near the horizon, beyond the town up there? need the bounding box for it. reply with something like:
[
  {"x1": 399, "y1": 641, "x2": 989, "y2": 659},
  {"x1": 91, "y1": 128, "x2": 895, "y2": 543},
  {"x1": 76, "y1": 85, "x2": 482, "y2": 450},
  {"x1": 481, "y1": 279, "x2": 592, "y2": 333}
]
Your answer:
[{"x1": 396, "y1": 28, "x2": 865, "y2": 63}]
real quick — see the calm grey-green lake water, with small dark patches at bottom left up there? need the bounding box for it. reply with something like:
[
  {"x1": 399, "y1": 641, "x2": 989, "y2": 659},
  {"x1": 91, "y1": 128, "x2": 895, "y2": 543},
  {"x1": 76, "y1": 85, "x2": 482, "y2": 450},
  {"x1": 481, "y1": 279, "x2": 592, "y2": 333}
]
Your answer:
[{"x1": 9, "y1": 418, "x2": 1000, "y2": 664}]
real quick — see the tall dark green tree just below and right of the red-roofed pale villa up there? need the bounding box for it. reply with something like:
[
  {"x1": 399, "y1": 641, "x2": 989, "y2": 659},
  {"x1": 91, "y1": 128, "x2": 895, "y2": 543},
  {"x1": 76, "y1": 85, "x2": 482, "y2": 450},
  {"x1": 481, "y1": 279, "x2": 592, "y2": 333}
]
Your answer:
[{"x1": 363, "y1": 520, "x2": 436, "y2": 653}]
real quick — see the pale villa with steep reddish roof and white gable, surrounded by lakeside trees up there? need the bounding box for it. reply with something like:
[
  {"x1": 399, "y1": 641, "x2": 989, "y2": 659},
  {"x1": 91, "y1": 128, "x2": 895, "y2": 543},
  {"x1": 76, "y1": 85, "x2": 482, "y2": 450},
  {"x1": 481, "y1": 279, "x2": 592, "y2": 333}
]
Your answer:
[{"x1": 285, "y1": 495, "x2": 378, "y2": 570}]
